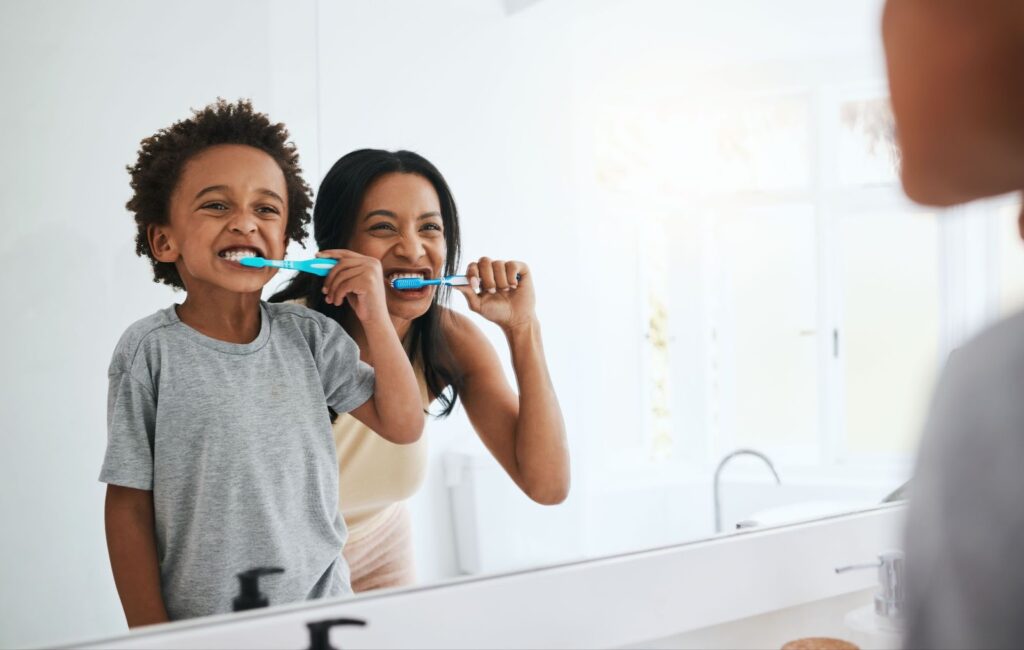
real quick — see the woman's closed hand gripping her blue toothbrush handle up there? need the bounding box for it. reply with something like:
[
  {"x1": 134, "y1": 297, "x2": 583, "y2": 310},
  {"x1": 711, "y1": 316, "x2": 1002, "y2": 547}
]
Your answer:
[{"x1": 456, "y1": 257, "x2": 536, "y2": 332}]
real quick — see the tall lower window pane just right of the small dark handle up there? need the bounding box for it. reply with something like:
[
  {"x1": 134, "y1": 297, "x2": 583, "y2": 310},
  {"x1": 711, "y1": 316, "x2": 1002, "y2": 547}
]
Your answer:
[{"x1": 840, "y1": 212, "x2": 940, "y2": 454}]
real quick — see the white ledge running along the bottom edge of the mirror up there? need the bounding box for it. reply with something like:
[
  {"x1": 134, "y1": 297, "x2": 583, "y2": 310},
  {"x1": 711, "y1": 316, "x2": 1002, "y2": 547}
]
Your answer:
[{"x1": 77, "y1": 505, "x2": 903, "y2": 649}]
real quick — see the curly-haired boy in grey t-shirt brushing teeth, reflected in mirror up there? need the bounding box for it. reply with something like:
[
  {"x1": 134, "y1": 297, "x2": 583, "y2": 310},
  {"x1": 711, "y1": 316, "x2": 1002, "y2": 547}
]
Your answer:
[{"x1": 100, "y1": 100, "x2": 424, "y2": 627}]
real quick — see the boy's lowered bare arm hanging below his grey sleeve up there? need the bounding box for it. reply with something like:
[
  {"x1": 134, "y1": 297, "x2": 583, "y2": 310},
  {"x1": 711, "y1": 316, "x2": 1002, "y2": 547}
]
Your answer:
[{"x1": 104, "y1": 484, "x2": 168, "y2": 627}]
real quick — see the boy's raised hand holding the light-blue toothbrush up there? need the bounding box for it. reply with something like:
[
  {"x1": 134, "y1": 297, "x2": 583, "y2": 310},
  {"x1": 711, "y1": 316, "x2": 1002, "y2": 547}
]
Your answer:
[{"x1": 316, "y1": 249, "x2": 390, "y2": 324}]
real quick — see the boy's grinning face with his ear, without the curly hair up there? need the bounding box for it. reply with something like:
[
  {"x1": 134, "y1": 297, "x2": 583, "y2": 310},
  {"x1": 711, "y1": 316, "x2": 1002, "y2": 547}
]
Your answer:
[{"x1": 150, "y1": 144, "x2": 288, "y2": 298}]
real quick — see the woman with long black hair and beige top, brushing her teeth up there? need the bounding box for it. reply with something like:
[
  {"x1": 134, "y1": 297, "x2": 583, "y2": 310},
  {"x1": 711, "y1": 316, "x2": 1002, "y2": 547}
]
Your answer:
[{"x1": 271, "y1": 149, "x2": 569, "y2": 592}]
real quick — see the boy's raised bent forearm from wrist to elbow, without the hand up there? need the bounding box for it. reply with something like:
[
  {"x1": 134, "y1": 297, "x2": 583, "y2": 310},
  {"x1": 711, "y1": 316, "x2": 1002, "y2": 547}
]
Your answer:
[{"x1": 349, "y1": 317, "x2": 424, "y2": 444}]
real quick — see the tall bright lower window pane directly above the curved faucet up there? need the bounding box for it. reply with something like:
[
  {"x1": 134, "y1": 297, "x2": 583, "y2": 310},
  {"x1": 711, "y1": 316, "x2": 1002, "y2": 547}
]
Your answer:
[{"x1": 713, "y1": 205, "x2": 819, "y2": 461}]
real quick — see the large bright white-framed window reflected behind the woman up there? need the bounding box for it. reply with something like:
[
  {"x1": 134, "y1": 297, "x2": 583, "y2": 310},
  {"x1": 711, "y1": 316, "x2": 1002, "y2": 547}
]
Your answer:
[{"x1": 593, "y1": 72, "x2": 1011, "y2": 479}]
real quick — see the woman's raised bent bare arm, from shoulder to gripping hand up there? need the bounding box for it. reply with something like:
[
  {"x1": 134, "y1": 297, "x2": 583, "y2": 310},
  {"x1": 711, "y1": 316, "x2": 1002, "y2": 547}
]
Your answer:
[{"x1": 445, "y1": 258, "x2": 569, "y2": 505}]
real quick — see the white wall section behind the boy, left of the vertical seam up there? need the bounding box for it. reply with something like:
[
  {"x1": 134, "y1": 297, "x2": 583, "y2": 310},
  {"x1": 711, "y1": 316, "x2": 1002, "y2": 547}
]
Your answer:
[{"x1": 0, "y1": 0, "x2": 316, "y2": 647}]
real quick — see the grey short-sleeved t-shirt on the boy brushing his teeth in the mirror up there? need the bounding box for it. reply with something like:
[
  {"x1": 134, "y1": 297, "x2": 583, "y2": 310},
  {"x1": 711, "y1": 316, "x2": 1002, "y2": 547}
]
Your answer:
[{"x1": 99, "y1": 303, "x2": 374, "y2": 619}]
